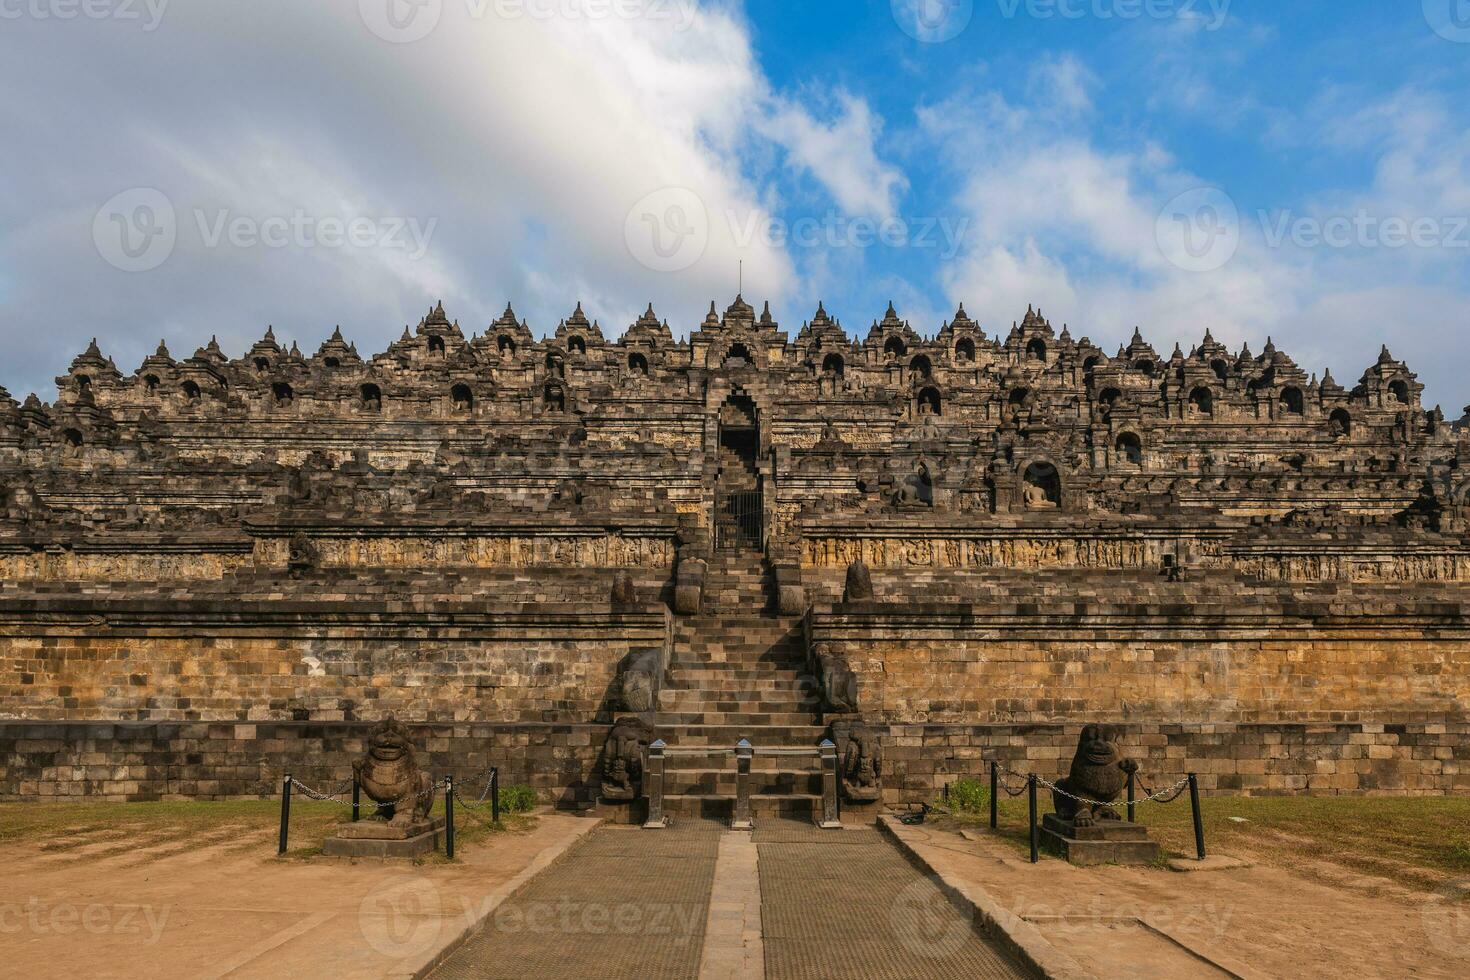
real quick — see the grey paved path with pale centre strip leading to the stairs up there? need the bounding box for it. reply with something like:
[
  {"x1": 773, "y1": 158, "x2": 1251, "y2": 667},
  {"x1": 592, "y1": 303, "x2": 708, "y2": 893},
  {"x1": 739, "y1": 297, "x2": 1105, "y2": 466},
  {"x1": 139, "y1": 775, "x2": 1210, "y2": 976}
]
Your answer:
[{"x1": 434, "y1": 820, "x2": 1028, "y2": 980}]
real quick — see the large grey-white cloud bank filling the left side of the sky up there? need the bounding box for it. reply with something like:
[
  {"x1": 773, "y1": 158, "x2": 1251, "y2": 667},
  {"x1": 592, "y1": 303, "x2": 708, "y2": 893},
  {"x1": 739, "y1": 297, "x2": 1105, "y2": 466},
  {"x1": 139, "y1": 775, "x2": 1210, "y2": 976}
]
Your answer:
[{"x1": 0, "y1": 0, "x2": 901, "y2": 397}]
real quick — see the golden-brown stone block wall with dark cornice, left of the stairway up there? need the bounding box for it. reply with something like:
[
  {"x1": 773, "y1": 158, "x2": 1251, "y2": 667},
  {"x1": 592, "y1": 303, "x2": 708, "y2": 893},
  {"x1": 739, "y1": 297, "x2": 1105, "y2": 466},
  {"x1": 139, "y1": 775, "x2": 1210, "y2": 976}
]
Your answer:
[{"x1": 0, "y1": 601, "x2": 669, "y2": 724}]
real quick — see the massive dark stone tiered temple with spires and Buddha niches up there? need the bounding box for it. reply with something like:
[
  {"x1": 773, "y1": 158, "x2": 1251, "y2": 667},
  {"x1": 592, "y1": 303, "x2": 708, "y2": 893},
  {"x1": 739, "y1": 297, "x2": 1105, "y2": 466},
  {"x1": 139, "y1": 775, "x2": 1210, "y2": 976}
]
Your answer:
[{"x1": 0, "y1": 298, "x2": 1470, "y2": 811}]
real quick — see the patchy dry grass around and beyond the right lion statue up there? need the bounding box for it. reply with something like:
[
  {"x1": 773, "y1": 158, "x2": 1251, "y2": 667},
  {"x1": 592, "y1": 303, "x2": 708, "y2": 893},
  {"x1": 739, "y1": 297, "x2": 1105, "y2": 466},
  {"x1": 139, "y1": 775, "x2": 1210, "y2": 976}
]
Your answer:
[{"x1": 939, "y1": 788, "x2": 1470, "y2": 890}]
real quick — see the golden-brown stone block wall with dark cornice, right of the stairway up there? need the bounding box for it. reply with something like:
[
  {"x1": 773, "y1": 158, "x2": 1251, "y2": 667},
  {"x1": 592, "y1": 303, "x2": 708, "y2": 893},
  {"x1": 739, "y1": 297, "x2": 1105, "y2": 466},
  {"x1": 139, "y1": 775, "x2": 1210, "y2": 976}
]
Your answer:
[{"x1": 810, "y1": 598, "x2": 1470, "y2": 729}]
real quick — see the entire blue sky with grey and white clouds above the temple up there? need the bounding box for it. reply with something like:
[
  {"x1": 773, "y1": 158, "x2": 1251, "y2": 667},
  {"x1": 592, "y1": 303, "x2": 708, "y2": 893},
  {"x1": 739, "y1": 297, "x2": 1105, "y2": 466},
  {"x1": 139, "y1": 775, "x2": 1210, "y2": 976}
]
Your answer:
[{"x1": 0, "y1": 0, "x2": 1470, "y2": 405}]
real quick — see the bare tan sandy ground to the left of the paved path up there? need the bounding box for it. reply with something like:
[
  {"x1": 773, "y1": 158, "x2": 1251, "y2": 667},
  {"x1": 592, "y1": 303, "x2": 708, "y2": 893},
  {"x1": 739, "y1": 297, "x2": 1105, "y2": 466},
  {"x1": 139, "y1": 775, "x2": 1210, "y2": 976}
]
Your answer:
[{"x1": 0, "y1": 811, "x2": 597, "y2": 979}]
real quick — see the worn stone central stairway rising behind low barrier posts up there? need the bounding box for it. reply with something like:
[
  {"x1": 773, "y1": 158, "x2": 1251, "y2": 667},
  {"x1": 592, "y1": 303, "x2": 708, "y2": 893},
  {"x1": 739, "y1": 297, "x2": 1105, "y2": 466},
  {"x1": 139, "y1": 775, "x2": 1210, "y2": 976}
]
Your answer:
[{"x1": 659, "y1": 551, "x2": 826, "y2": 818}]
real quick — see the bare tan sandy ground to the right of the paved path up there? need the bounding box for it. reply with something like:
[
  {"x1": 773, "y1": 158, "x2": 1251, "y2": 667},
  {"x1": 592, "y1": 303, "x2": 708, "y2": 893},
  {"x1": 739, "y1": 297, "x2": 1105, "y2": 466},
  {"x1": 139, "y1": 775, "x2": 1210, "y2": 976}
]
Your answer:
[{"x1": 882, "y1": 826, "x2": 1470, "y2": 979}]
